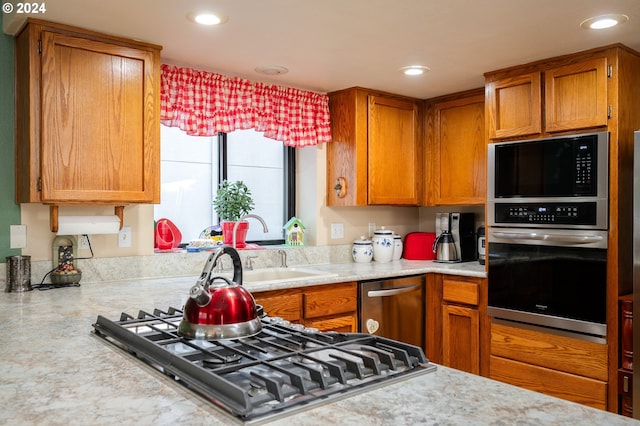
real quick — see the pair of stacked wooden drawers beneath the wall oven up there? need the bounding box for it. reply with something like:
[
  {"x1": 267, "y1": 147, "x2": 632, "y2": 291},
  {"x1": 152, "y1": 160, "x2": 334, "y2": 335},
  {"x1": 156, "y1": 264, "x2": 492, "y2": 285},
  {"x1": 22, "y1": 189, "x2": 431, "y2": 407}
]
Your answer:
[{"x1": 489, "y1": 322, "x2": 608, "y2": 410}]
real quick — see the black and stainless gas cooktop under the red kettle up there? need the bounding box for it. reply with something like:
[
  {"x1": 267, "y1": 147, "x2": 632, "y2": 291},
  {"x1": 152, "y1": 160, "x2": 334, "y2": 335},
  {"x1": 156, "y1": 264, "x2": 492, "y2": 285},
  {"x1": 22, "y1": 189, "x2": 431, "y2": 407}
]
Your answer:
[{"x1": 93, "y1": 308, "x2": 436, "y2": 424}]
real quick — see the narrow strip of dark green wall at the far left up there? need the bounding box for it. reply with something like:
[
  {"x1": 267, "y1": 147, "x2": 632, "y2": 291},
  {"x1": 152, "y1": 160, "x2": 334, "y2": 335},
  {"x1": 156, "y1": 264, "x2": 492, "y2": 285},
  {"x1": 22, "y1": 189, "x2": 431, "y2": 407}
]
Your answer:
[{"x1": 0, "y1": 13, "x2": 20, "y2": 263}]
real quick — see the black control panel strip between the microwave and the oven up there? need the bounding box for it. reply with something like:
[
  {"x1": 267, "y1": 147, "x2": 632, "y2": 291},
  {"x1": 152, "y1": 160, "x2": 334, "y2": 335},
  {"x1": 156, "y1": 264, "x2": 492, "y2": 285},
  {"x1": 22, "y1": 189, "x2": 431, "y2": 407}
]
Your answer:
[{"x1": 495, "y1": 203, "x2": 596, "y2": 225}]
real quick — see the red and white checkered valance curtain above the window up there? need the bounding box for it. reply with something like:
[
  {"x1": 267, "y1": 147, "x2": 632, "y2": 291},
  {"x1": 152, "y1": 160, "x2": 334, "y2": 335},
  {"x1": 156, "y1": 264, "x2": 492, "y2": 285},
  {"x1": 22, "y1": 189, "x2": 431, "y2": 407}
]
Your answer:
[{"x1": 160, "y1": 64, "x2": 331, "y2": 147}]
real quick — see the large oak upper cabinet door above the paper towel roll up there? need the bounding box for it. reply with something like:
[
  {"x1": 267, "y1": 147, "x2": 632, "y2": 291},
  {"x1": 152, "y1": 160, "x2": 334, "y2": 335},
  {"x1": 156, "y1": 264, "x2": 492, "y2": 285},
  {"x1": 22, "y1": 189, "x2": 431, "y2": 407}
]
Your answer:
[{"x1": 40, "y1": 31, "x2": 160, "y2": 203}]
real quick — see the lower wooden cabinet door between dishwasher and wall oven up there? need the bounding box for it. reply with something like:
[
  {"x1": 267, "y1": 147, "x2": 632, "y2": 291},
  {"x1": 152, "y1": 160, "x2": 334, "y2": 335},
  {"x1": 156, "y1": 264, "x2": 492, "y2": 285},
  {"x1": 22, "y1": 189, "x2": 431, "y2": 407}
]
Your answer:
[{"x1": 442, "y1": 304, "x2": 480, "y2": 374}]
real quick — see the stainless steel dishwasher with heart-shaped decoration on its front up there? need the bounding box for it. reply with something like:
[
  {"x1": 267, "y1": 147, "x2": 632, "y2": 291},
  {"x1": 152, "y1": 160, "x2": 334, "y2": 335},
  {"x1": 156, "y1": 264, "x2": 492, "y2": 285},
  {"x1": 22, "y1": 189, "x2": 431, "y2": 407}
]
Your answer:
[{"x1": 358, "y1": 275, "x2": 425, "y2": 348}]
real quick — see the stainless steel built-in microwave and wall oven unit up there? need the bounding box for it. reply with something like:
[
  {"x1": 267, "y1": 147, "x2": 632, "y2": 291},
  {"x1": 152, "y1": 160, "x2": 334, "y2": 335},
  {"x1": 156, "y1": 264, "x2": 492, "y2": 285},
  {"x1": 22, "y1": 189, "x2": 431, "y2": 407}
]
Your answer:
[{"x1": 487, "y1": 132, "x2": 609, "y2": 340}]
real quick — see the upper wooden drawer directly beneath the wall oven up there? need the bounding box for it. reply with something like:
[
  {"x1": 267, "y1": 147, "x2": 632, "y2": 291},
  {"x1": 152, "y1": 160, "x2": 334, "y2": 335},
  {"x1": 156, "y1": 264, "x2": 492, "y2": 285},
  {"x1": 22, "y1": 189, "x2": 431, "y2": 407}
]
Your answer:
[{"x1": 491, "y1": 324, "x2": 609, "y2": 381}]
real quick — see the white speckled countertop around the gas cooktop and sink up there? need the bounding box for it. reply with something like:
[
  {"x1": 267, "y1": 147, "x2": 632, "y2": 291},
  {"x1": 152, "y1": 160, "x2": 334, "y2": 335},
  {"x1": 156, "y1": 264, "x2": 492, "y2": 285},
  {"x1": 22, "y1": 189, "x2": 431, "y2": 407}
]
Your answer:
[{"x1": 0, "y1": 255, "x2": 638, "y2": 425}]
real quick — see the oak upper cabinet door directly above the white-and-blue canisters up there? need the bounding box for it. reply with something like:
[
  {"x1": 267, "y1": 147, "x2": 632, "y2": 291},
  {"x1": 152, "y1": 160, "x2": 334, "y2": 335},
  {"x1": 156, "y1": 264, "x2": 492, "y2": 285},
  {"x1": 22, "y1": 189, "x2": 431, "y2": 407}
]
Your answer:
[{"x1": 368, "y1": 96, "x2": 422, "y2": 205}]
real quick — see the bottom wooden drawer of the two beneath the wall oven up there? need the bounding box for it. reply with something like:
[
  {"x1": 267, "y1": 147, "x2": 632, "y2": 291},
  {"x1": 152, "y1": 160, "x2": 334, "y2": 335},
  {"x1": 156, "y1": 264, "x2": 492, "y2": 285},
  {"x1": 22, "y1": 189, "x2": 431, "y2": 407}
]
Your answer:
[{"x1": 489, "y1": 355, "x2": 607, "y2": 410}]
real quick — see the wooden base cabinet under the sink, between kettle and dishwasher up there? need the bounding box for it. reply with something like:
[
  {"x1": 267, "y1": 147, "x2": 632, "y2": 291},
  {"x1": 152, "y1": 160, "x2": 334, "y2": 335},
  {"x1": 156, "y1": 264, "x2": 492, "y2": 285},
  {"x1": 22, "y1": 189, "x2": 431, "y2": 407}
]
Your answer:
[{"x1": 253, "y1": 282, "x2": 358, "y2": 333}]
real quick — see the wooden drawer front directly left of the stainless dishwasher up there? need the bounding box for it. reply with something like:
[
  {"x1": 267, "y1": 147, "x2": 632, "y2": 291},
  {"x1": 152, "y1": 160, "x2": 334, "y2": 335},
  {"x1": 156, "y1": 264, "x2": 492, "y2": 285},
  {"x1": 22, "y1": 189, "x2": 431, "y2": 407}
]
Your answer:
[{"x1": 303, "y1": 283, "x2": 358, "y2": 318}]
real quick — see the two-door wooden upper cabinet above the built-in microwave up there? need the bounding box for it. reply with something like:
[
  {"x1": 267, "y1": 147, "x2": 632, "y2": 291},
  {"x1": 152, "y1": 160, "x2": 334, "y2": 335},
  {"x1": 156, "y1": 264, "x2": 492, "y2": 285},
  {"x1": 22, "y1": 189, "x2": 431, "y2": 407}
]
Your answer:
[{"x1": 485, "y1": 56, "x2": 608, "y2": 139}]
